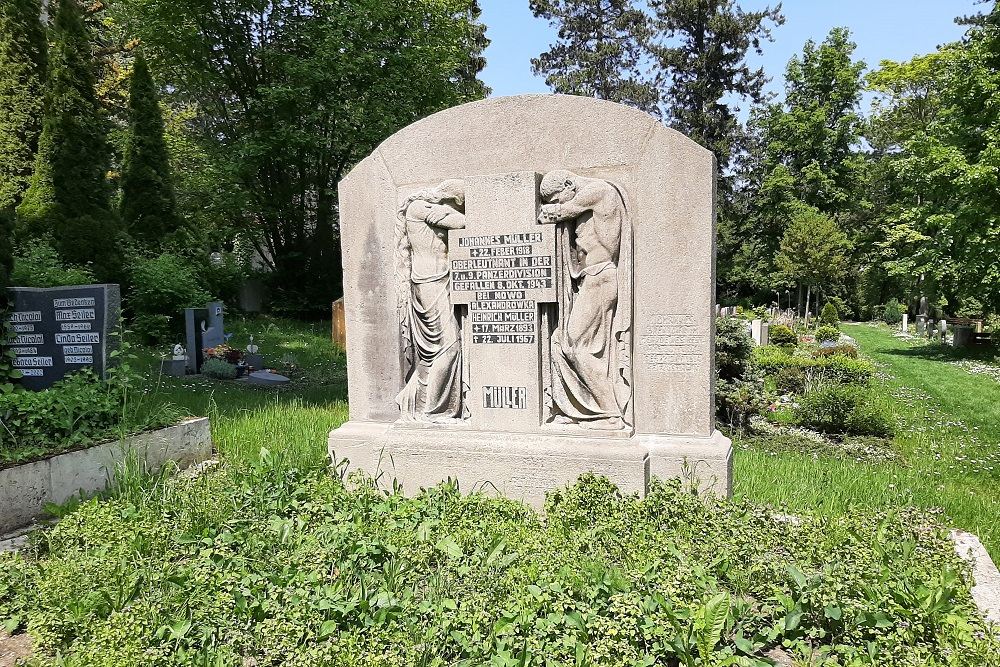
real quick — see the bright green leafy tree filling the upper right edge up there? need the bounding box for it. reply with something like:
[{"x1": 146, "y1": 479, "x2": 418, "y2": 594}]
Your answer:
[{"x1": 873, "y1": 8, "x2": 1000, "y2": 312}]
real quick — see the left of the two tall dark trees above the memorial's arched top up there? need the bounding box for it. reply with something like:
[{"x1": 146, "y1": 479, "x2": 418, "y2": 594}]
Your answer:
[{"x1": 528, "y1": 0, "x2": 659, "y2": 112}]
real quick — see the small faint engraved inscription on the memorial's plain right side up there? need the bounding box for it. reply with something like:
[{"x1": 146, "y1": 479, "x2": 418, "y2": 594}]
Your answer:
[{"x1": 639, "y1": 313, "x2": 708, "y2": 373}]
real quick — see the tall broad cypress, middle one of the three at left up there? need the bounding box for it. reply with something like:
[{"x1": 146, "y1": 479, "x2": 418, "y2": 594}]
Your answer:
[{"x1": 17, "y1": 0, "x2": 121, "y2": 280}]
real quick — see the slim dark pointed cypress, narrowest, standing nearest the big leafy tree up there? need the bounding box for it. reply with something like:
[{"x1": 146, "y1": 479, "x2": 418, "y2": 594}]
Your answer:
[{"x1": 121, "y1": 53, "x2": 179, "y2": 248}]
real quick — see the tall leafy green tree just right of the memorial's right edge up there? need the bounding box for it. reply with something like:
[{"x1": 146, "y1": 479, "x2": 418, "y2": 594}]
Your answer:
[{"x1": 719, "y1": 28, "x2": 870, "y2": 304}]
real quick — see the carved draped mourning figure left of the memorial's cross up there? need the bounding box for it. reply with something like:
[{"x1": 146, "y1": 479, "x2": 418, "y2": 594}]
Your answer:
[{"x1": 395, "y1": 179, "x2": 465, "y2": 421}]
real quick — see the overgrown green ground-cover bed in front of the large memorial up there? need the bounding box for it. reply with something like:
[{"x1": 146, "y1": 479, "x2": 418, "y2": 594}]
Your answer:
[{"x1": 0, "y1": 462, "x2": 1000, "y2": 667}]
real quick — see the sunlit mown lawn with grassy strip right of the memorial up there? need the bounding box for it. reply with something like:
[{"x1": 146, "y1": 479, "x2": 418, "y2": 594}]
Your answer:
[{"x1": 733, "y1": 324, "x2": 1000, "y2": 561}]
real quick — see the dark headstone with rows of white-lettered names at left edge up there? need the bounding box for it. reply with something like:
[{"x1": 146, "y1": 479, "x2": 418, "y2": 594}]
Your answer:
[{"x1": 7, "y1": 285, "x2": 121, "y2": 390}]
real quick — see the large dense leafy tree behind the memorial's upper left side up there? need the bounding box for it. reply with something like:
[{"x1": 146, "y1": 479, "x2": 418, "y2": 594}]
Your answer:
[{"x1": 109, "y1": 0, "x2": 488, "y2": 313}]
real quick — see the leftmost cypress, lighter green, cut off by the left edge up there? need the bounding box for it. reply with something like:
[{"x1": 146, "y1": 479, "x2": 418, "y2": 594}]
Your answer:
[{"x1": 0, "y1": 0, "x2": 48, "y2": 210}]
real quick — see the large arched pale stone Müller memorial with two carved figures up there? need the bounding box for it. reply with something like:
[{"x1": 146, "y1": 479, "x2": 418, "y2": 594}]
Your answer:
[{"x1": 330, "y1": 95, "x2": 732, "y2": 505}]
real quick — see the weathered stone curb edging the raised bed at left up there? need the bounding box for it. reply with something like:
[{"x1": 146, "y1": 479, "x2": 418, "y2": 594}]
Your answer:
[{"x1": 0, "y1": 417, "x2": 212, "y2": 535}]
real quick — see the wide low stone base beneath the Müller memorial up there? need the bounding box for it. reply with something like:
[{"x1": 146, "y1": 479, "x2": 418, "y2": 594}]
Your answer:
[{"x1": 329, "y1": 421, "x2": 733, "y2": 508}]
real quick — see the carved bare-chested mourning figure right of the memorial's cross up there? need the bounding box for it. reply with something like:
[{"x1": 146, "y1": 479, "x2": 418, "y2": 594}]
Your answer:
[{"x1": 539, "y1": 170, "x2": 632, "y2": 430}]
